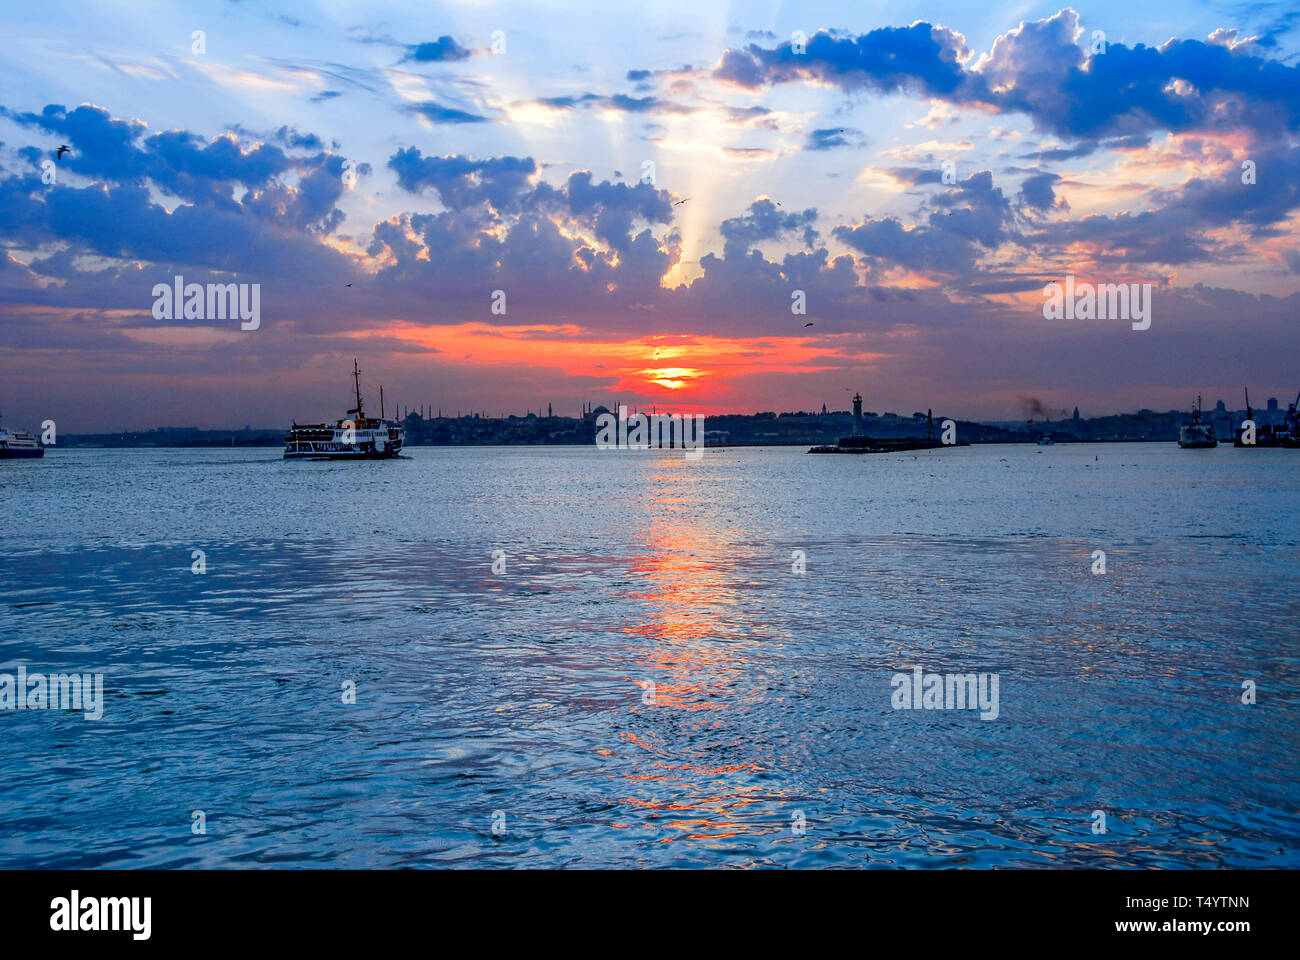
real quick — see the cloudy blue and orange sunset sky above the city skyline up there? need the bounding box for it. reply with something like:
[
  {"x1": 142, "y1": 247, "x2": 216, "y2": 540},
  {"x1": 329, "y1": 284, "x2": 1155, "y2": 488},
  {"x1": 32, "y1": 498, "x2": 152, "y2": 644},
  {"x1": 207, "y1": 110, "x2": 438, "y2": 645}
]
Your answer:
[{"x1": 0, "y1": 0, "x2": 1300, "y2": 433}]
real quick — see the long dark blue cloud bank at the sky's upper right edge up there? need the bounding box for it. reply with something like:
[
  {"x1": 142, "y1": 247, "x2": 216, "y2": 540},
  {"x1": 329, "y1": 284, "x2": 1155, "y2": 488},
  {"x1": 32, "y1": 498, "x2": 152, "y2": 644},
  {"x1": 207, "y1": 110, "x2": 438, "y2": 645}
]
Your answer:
[{"x1": 714, "y1": 8, "x2": 1300, "y2": 141}]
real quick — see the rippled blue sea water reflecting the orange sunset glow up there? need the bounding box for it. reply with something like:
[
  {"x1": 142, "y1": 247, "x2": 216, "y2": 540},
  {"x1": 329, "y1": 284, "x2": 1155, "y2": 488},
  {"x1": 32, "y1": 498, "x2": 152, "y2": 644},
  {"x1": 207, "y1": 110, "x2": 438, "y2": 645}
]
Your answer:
[{"x1": 0, "y1": 444, "x2": 1300, "y2": 868}]
